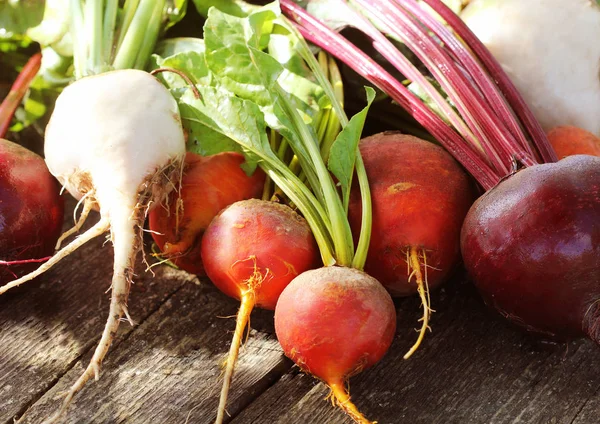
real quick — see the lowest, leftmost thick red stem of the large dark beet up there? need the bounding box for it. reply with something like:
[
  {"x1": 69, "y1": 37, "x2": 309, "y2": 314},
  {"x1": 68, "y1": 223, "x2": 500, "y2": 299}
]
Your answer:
[{"x1": 280, "y1": 0, "x2": 500, "y2": 190}]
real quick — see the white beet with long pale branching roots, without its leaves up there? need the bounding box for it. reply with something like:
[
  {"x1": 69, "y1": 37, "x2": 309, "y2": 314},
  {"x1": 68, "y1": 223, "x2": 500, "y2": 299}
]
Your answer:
[{"x1": 0, "y1": 70, "x2": 185, "y2": 422}]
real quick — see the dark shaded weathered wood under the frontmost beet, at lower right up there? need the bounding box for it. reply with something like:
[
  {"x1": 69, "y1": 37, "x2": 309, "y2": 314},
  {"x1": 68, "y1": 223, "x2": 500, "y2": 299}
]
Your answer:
[{"x1": 233, "y1": 276, "x2": 600, "y2": 424}]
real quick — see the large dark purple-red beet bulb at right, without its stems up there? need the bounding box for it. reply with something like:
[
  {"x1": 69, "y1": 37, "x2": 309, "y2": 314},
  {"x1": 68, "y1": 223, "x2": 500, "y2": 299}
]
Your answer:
[{"x1": 461, "y1": 155, "x2": 600, "y2": 342}]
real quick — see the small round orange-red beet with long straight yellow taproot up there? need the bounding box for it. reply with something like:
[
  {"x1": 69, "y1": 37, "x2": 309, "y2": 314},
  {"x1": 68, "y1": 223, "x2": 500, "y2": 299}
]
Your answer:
[{"x1": 202, "y1": 199, "x2": 320, "y2": 423}]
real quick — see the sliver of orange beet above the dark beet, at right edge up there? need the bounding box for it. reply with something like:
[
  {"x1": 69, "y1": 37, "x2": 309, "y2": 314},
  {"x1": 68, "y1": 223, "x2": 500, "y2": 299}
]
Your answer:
[{"x1": 548, "y1": 125, "x2": 600, "y2": 159}]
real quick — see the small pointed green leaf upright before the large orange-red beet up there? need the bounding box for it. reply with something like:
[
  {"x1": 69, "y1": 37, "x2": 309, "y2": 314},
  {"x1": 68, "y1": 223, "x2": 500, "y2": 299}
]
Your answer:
[{"x1": 327, "y1": 87, "x2": 375, "y2": 209}]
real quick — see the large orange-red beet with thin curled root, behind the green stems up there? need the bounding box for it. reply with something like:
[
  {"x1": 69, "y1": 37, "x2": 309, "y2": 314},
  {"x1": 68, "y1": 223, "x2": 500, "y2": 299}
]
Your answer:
[{"x1": 349, "y1": 132, "x2": 475, "y2": 358}]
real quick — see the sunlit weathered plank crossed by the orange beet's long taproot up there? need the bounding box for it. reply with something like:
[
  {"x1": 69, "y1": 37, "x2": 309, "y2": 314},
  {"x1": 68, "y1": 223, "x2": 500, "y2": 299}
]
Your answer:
[{"x1": 17, "y1": 282, "x2": 291, "y2": 424}]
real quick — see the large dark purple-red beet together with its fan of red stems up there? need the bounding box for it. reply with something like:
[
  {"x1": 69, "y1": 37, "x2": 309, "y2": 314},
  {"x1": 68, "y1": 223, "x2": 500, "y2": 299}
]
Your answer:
[{"x1": 282, "y1": 0, "x2": 600, "y2": 350}]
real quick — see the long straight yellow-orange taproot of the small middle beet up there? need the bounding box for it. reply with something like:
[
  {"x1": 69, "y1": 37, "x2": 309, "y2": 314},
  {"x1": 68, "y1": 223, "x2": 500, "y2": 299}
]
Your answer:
[{"x1": 215, "y1": 290, "x2": 254, "y2": 424}]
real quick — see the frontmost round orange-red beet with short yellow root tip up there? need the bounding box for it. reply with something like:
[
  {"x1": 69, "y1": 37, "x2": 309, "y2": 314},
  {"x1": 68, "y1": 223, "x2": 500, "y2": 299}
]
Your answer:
[{"x1": 275, "y1": 267, "x2": 396, "y2": 423}]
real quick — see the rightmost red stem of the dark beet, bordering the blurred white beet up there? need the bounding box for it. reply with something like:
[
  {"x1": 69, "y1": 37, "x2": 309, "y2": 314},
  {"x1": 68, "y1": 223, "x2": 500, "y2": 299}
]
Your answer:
[{"x1": 424, "y1": 0, "x2": 557, "y2": 162}]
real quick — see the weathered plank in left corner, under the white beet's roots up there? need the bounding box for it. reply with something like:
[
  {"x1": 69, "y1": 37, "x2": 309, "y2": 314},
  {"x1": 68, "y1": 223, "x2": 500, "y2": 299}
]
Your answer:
[{"x1": 0, "y1": 204, "x2": 195, "y2": 423}]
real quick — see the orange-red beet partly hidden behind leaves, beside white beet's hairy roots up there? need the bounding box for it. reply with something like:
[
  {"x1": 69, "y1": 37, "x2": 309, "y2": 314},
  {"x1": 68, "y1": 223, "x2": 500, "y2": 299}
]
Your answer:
[{"x1": 149, "y1": 152, "x2": 265, "y2": 275}]
